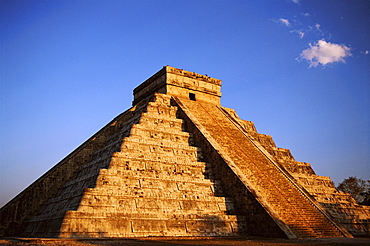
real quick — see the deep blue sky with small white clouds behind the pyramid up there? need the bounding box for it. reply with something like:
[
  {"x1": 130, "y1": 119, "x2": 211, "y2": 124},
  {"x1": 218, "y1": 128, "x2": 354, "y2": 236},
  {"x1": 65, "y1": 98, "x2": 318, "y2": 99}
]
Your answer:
[{"x1": 0, "y1": 0, "x2": 370, "y2": 206}]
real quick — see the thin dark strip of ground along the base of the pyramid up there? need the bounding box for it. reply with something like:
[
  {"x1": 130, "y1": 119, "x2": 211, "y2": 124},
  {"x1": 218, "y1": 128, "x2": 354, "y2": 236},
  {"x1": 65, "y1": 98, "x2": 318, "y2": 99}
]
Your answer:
[{"x1": 0, "y1": 237, "x2": 370, "y2": 246}]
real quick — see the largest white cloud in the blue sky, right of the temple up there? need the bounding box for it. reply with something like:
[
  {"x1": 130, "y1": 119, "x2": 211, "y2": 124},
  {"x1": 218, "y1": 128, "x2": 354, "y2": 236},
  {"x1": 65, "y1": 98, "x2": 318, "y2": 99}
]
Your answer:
[{"x1": 300, "y1": 39, "x2": 352, "y2": 67}]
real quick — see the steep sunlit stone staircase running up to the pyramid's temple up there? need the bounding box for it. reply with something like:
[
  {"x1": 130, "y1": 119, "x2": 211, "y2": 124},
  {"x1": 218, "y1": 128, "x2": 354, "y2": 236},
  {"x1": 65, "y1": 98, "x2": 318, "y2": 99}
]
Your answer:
[{"x1": 175, "y1": 98, "x2": 351, "y2": 238}]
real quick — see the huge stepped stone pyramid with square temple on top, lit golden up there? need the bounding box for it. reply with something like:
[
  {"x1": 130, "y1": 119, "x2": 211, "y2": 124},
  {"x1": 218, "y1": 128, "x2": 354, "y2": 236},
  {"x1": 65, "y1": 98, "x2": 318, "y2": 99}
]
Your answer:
[{"x1": 0, "y1": 66, "x2": 370, "y2": 238}]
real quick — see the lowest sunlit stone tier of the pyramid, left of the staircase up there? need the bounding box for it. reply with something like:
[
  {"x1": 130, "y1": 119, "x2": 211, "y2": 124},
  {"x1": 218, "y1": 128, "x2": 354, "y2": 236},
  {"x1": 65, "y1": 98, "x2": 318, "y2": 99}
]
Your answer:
[{"x1": 60, "y1": 211, "x2": 239, "y2": 237}]
